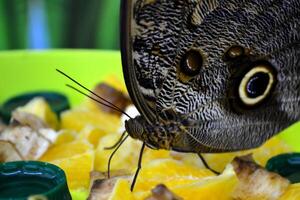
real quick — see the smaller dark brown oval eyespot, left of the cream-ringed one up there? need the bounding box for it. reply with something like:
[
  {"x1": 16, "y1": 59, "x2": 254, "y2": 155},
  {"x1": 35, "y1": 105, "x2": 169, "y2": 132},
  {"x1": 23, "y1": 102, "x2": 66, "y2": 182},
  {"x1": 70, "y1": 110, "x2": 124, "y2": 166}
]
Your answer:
[{"x1": 180, "y1": 50, "x2": 203, "y2": 77}]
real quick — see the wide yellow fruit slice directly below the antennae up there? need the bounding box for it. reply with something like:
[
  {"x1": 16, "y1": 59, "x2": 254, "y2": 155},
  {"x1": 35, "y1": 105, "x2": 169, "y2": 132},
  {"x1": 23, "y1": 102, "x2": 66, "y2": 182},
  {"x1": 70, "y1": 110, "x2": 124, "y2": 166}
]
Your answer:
[{"x1": 61, "y1": 107, "x2": 121, "y2": 133}]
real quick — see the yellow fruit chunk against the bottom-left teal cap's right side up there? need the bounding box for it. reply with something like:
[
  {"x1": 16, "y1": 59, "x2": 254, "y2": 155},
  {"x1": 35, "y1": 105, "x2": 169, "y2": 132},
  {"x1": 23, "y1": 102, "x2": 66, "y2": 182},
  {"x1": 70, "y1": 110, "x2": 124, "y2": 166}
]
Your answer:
[{"x1": 49, "y1": 151, "x2": 95, "y2": 189}]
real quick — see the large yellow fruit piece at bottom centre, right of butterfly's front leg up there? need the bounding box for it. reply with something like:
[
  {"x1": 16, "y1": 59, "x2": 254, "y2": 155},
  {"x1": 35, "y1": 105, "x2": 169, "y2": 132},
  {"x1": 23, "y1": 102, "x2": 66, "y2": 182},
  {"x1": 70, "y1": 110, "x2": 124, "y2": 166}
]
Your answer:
[{"x1": 134, "y1": 163, "x2": 238, "y2": 200}]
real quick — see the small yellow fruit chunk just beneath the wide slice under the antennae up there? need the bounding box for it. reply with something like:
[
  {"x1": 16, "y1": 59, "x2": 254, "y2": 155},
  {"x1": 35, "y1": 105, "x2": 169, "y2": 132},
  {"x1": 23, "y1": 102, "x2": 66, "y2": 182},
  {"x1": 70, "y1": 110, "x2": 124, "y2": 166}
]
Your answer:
[{"x1": 79, "y1": 126, "x2": 107, "y2": 148}]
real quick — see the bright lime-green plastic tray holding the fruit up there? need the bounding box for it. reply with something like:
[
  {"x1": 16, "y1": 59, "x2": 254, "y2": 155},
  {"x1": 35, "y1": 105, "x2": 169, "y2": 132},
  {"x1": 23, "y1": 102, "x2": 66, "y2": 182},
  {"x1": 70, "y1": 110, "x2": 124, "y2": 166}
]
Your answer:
[{"x1": 0, "y1": 50, "x2": 300, "y2": 151}]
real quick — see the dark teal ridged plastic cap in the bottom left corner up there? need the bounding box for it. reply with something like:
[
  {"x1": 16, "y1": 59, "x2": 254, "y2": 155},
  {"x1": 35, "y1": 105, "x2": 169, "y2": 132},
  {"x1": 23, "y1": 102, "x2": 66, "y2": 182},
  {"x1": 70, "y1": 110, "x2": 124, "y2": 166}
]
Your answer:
[{"x1": 0, "y1": 161, "x2": 72, "y2": 200}]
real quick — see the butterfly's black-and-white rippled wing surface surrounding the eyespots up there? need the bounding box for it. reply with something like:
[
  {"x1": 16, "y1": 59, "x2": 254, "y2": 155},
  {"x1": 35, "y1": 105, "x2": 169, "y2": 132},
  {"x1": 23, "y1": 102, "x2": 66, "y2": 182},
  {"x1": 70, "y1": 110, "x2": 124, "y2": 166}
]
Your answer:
[{"x1": 121, "y1": 0, "x2": 300, "y2": 152}]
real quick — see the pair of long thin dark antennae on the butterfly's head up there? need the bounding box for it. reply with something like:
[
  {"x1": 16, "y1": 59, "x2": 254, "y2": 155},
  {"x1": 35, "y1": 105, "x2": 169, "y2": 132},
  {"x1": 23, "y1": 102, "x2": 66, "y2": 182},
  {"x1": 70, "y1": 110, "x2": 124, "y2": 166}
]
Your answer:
[{"x1": 56, "y1": 69, "x2": 132, "y2": 119}]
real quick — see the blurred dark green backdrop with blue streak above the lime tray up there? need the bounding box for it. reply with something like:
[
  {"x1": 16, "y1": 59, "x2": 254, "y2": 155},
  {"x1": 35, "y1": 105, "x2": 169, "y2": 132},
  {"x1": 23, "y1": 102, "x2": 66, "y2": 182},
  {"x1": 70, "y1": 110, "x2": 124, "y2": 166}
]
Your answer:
[{"x1": 0, "y1": 0, "x2": 120, "y2": 50}]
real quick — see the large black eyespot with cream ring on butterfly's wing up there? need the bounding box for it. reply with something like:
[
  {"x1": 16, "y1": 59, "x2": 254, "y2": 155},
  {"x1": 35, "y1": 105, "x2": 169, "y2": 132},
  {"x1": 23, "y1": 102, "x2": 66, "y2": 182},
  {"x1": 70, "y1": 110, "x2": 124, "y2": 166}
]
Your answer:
[{"x1": 238, "y1": 65, "x2": 276, "y2": 106}]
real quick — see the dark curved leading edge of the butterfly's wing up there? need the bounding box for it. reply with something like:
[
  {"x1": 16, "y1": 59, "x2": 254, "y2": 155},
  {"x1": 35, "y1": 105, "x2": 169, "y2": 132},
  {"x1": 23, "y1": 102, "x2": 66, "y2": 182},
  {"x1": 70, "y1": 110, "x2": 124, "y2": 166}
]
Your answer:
[{"x1": 120, "y1": 0, "x2": 155, "y2": 122}]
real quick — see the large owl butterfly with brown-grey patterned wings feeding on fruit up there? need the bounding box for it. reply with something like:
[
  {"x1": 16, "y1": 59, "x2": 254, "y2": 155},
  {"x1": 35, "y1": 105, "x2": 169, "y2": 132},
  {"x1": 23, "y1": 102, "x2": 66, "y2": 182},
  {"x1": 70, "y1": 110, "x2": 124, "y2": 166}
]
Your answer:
[{"x1": 121, "y1": 0, "x2": 300, "y2": 188}]
